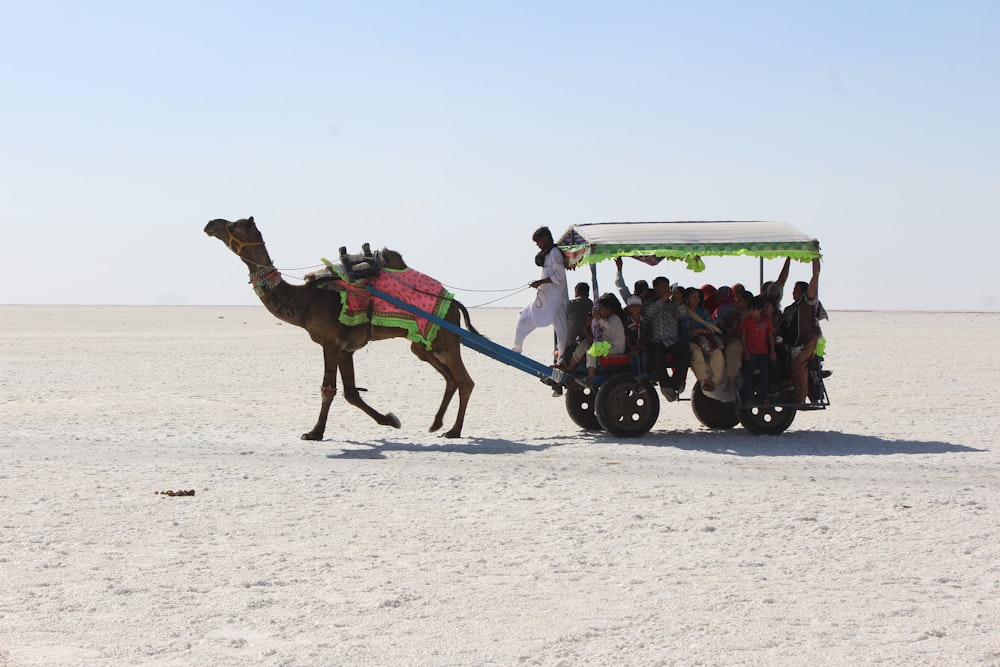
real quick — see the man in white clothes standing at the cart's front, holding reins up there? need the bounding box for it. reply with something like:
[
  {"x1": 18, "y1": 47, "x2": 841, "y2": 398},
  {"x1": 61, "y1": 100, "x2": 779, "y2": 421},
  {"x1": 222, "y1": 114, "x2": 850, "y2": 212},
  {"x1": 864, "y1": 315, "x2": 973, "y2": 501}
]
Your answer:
[{"x1": 513, "y1": 227, "x2": 570, "y2": 361}]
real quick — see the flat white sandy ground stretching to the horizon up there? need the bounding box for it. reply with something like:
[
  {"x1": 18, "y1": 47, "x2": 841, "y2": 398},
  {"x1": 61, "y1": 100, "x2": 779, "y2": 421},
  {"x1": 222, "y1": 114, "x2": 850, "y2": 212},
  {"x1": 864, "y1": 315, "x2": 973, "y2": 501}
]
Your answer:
[{"x1": 0, "y1": 306, "x2": 1000, "y2": 666}]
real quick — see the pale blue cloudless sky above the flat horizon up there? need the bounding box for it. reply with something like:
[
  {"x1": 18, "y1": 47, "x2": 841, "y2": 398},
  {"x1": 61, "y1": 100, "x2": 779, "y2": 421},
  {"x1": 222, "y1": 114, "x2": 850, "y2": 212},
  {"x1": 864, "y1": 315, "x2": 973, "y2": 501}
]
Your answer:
[{"x1": 0, "y1": 0, "x2": 1000, "y2": 311}]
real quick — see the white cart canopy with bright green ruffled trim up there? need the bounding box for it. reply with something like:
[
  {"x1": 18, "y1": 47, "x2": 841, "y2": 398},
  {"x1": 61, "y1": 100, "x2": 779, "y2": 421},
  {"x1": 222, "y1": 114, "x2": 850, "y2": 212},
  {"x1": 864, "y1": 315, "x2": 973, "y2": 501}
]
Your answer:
[{"x1": 556, "y1": 220, "x2": 822, "y2": 272}]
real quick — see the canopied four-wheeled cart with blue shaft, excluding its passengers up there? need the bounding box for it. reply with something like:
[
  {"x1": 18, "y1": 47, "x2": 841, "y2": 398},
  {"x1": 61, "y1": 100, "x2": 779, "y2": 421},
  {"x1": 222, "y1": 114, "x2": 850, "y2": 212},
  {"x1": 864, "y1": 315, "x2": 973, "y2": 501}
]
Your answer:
[{"x1": 366, "y1": 221, "x2": 830, "y2": 437}]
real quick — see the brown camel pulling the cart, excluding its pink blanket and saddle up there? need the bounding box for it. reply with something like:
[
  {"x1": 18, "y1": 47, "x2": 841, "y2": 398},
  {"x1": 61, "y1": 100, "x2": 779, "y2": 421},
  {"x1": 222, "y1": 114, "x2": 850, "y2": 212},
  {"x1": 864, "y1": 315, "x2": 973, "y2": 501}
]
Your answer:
[{"x1": 205, "y1": 217, "x2": 475, "y2": 440}]
